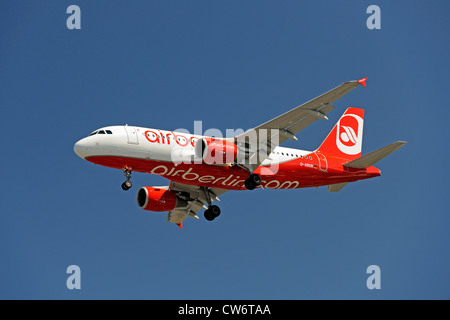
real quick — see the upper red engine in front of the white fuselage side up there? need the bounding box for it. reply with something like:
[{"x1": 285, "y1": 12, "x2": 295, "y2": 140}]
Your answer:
[{"x1": 195, "y1": 138, "x2": 238, "y2": 165}]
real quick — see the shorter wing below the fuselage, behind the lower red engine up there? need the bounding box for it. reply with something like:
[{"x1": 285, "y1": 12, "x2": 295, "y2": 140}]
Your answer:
[{"x1": 167, "y1": 181, "x2": 229, "y2": 228}]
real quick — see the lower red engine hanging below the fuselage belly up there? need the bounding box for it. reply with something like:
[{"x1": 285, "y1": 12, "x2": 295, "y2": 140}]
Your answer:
[{"x1": 136, "y1": 187, "x2": 178, "y2": 211}]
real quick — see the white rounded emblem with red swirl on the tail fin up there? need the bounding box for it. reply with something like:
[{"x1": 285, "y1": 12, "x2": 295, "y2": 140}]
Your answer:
[{"x1": 336, "y1": 114, "x2": 364, "y2": 155}]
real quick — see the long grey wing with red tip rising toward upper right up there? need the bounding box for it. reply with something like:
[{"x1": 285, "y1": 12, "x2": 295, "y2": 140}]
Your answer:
[{"x1": 235, "y1": 78, "x2": 367, "y2": 172}]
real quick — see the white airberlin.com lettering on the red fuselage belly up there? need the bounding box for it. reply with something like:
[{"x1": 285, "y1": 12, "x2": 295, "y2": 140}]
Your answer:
[{"x1": 150, "y1": 165, "x2": 300, "y2": 189}]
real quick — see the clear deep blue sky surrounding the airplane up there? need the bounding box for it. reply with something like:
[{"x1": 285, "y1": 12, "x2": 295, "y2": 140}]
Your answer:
[{"x1": 0, "y1": 0, "x2": 450, "y2": 299}]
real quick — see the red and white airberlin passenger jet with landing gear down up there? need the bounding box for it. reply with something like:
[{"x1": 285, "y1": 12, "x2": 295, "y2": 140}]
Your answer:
[{"x1": 74, "y1": 78, "x2": 407, "y2": 228}]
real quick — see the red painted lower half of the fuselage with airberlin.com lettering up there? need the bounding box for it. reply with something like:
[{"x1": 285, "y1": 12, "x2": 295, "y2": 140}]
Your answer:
[{"x1": 86, "y1": 153, "x2": 380, "y2": 190}]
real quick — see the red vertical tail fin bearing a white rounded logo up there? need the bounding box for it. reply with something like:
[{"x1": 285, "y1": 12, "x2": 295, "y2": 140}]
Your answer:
[{"x1": 317, "y1": 108, "x2": 364, "y2": 160}]
